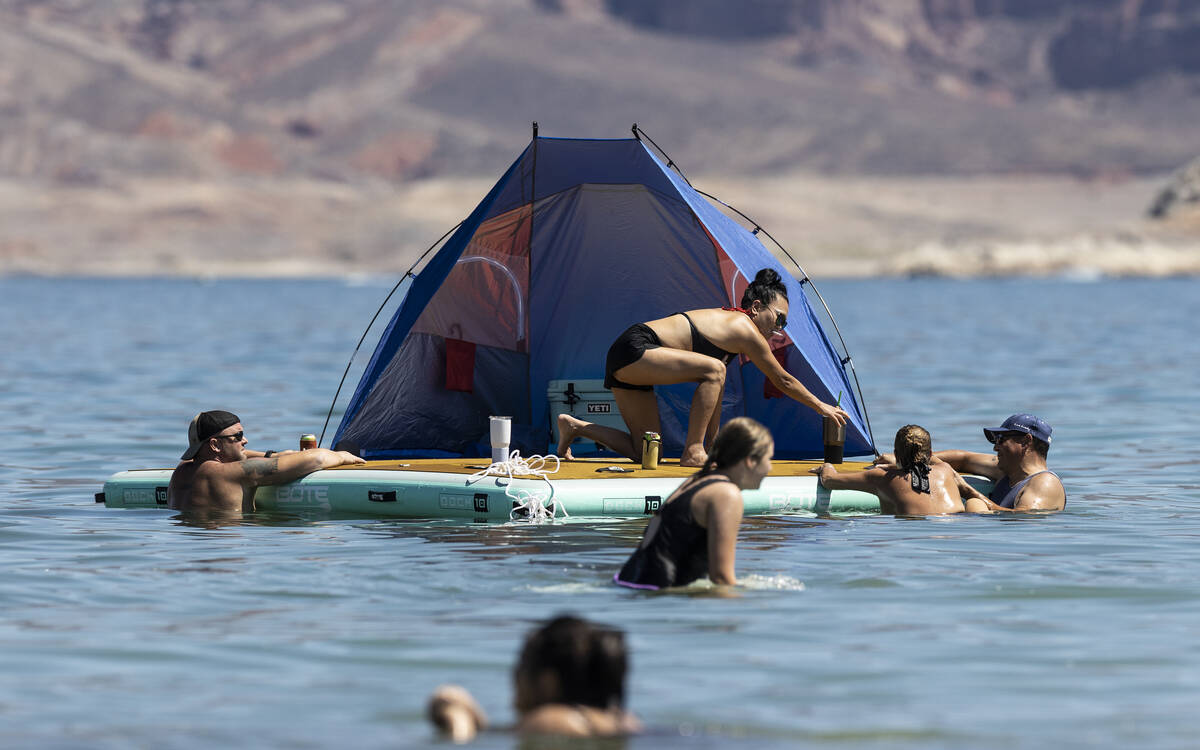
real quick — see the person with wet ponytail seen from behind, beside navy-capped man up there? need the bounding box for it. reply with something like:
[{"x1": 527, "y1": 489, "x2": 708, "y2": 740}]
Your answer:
[{"x1": 812, "y1": 425, "x2": 964, "y2": 516}]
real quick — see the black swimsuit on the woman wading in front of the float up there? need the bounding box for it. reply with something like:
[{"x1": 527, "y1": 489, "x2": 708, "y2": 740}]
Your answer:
[{"x1": 613, "y1": 476, "x2": 731, "y2": 589}]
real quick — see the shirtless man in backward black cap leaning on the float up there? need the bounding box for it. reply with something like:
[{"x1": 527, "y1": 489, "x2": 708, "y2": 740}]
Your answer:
[{"x1": 167, "y1": 410, "x2": 366, "y2": 516}]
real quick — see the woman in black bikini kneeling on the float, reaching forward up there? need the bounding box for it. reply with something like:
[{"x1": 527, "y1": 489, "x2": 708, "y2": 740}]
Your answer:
[{"x1": 557, "y1": 269, "x2": 850, "y2": 467}]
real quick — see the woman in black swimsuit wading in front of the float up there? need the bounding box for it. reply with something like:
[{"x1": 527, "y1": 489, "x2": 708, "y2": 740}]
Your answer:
[{"x1": 613, "y1": 416, "x2": 775, "y2": 589}]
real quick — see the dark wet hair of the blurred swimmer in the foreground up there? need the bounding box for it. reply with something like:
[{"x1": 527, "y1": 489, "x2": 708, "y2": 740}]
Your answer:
[{"x1": 512, "y1": 614, "x2": 628, "y2": 713}]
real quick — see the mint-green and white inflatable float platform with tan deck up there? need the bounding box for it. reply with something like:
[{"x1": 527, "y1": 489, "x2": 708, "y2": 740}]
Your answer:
[{"x1": 96, "y1": 458, "x2": 991, "y2": 523}]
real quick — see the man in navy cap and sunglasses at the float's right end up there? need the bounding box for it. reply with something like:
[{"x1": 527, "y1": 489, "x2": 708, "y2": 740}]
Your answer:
[{"x1": 934, "y1": 414, "x2": 1067, "y2": 512}]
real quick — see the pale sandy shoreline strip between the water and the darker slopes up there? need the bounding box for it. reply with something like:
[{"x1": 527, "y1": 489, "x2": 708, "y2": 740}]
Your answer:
[{"x1": 0, "y1": 174, "x2": 1200, "y2": 280}]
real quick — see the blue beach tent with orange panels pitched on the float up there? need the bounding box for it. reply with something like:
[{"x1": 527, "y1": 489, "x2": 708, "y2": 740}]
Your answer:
[{"x1": 334, "y1": 126, "x2": 874, "y2": 458}]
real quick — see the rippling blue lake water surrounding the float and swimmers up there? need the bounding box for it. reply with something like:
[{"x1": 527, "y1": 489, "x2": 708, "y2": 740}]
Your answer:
[{"x1": 0, "y1": 278, "x2": 1200, "y2": 750}]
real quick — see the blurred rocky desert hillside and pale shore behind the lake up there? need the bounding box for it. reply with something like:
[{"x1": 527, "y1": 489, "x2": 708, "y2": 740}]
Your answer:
[{"x1": 0, "y1": 0, "x2": 1200, "y2": 276}]
